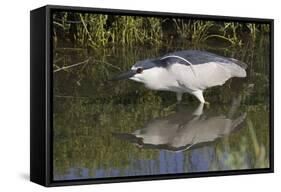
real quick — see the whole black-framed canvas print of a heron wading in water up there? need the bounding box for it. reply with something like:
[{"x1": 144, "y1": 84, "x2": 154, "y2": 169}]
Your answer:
[{"x1": 30, "y1": 5, "x2": 273, "y2": 186}]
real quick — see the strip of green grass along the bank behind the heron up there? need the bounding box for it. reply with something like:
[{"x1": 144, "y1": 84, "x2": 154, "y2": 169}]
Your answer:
[{"x1": 53, "y1": 12, "x2": 269, "y2": 48}]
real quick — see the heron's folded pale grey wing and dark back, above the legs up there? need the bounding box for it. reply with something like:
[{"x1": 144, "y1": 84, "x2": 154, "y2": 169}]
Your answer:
[{"x1": 159, "y1": 50, "x2": 246, "y2": 90}]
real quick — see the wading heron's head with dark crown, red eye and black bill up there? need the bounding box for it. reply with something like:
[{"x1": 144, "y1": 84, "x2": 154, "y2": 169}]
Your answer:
[{"x1": 110, "y1": 60, "x2": 158, "y2": 83}]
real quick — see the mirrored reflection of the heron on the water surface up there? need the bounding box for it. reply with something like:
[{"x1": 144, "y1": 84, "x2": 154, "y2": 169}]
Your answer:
[{"x1": 114, "y1": 98, "x2": 246, "y2": 151}]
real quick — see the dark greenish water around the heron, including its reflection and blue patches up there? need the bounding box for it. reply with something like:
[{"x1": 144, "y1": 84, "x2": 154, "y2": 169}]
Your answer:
[{"x1": 53, "y1": 41, "x2": 269, "y2": 180}]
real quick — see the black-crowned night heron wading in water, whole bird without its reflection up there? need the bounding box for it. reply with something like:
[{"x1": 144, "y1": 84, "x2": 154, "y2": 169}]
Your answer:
[{"x1": 114, "y1": 50, "x2": 246, "y2": 103}]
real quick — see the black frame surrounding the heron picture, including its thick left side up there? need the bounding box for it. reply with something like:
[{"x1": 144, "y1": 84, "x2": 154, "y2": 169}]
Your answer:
[{"x1": 30, "y1": 5, "x2": 274, "y2": 187}]
